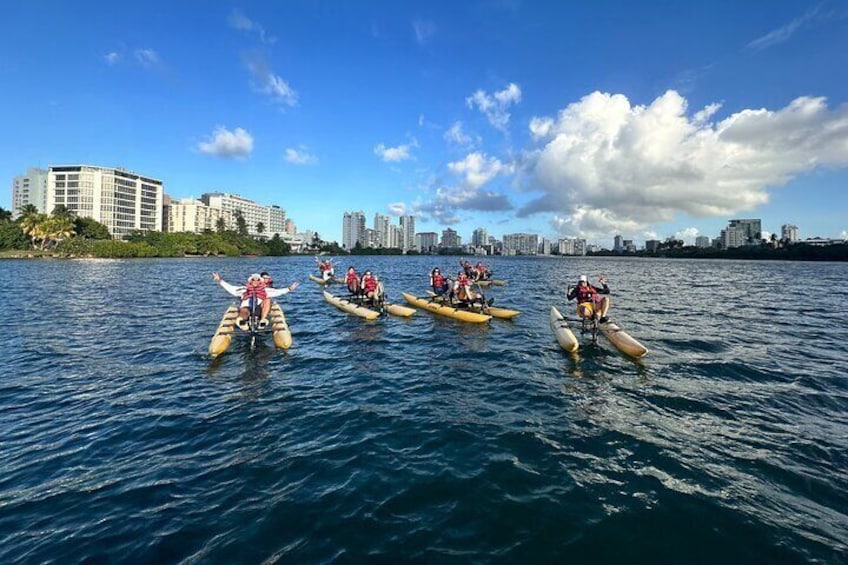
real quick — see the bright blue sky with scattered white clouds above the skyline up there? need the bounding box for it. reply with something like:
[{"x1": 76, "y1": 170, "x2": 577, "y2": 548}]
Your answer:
[{"x1": 0, "y1": 0, "x2": 848, "y2": 246}]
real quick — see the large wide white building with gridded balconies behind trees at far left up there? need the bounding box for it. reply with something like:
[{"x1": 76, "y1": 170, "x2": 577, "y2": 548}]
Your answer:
[{"x1": 45, "y1": 165, "x2": 164, "y2": 238}]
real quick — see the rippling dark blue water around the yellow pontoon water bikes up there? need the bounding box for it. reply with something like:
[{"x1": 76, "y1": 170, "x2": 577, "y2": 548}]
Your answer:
[{"x1": 0, "y1": 257, "x2": 848, "y2": 563}]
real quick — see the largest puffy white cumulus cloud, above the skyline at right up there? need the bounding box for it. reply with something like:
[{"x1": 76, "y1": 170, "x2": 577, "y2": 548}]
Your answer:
[{"x1": 519, "y1": 91, "x2": 848, "y2": 236}]
